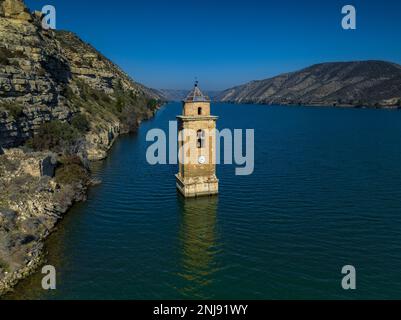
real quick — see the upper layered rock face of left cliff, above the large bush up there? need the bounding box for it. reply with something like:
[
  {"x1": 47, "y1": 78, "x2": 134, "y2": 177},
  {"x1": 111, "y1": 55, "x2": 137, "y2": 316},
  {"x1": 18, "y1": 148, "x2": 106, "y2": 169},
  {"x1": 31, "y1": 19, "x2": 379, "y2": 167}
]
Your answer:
[{"x1": 0, "y1": 0, "x2": 160, "y2": 158}]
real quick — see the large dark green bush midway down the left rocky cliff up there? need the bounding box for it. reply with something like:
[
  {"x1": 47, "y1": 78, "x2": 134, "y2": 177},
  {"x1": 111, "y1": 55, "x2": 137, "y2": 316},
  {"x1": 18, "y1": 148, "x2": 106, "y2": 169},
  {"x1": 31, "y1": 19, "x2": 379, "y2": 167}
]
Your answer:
[{"x1": 27, "y1": 120, "x2": 79, "y2": 152}]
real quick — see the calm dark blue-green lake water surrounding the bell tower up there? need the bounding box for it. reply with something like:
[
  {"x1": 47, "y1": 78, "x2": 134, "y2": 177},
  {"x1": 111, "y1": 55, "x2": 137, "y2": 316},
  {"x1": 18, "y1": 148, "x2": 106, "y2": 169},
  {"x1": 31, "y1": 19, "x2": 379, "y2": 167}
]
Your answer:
[{"x1": 7, "y1": 103, "x2": 401, "y2": 299}]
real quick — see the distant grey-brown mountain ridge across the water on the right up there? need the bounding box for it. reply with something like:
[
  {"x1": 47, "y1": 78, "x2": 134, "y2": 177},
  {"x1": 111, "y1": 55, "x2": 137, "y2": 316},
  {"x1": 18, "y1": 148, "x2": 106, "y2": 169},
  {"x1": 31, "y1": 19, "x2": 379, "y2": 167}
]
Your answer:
[{"x1": 216, "y1": 60, "x2": 401, "y2": 107}]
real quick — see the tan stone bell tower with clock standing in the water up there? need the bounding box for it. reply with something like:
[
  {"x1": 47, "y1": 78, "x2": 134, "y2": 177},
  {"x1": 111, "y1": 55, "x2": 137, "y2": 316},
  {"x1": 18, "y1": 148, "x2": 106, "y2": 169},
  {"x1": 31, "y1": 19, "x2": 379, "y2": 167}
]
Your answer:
[{"x1": 176, "y1": 82, "x2": 219, "y2": 197}]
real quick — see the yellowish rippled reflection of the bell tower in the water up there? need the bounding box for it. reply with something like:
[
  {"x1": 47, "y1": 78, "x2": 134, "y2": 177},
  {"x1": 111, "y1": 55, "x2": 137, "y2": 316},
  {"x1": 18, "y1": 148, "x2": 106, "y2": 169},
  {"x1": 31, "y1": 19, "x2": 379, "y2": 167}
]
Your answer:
[{"x1": 178, "y1": 196, "x2": 222, "y2": 299}]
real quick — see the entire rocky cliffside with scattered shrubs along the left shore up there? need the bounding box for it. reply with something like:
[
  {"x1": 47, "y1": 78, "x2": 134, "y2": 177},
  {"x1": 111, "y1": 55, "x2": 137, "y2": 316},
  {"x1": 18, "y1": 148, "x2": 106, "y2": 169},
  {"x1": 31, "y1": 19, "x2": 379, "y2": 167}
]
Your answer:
[{"x1": 0, "y1": 0, "x2": 161, "y2": 295}]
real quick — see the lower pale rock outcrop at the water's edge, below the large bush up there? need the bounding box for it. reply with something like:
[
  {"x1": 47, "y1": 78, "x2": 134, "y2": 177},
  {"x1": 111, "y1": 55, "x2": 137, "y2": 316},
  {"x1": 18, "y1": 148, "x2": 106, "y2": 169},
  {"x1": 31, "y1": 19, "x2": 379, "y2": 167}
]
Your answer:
[{"x1": 0, "y1": 149, "x2": 87, "y2": 295}]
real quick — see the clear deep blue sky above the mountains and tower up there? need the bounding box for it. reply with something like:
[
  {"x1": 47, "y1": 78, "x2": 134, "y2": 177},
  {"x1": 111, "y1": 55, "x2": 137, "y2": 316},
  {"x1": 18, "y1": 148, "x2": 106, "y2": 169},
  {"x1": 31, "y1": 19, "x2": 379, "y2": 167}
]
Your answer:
[{"x1": 26, "y1": 0, "x2": 401, "y2": 90}]
